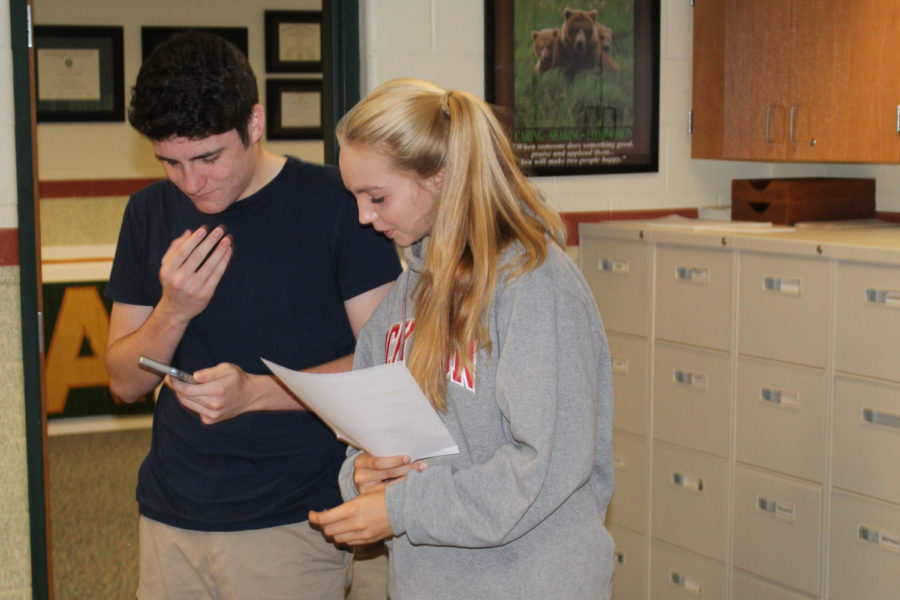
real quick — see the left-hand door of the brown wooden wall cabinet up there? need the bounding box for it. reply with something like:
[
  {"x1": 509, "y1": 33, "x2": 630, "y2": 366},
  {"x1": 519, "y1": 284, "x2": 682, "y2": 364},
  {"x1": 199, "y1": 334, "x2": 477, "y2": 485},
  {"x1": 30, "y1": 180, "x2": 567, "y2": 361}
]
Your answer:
[{"x1": 691, "y1": 0, "x2": 790, "y2": 160}]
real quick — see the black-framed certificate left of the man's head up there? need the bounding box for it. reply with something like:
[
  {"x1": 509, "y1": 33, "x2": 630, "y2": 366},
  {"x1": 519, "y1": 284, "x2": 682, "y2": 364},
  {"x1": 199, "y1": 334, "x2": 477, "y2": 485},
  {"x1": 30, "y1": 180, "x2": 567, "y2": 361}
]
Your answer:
[{"x1": 34, "y1": 25, "x2": 125, "y2": 123}]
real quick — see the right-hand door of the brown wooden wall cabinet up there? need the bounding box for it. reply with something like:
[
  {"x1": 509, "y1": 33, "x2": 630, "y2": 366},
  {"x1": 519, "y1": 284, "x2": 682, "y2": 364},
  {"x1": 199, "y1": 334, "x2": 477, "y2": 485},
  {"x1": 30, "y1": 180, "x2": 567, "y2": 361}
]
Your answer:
[{"x1": 789, "y1": 0, "x2": 900, "y2": 162}]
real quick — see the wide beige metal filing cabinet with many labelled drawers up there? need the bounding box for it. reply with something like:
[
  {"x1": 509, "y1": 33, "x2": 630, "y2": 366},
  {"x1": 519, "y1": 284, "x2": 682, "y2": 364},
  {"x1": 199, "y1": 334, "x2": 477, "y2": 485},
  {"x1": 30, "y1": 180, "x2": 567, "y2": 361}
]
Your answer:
[{"x1": 580, "y1": 221, "x2": 900, "y2": 600}]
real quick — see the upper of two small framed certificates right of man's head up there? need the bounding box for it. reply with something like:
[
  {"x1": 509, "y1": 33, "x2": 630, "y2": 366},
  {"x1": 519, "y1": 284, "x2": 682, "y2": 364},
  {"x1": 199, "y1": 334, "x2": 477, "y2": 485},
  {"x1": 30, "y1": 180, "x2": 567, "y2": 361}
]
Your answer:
[{"x1": 263, "y1": 10, "x2": 323, "y2": 73}]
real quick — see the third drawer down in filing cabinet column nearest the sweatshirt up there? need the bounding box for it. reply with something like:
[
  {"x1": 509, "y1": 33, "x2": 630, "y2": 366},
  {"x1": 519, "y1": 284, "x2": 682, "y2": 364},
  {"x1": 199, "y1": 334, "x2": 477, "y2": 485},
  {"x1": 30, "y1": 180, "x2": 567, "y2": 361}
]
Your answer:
[{"x1": 606, "y1": 431, "x2": 650, "y2": 533}]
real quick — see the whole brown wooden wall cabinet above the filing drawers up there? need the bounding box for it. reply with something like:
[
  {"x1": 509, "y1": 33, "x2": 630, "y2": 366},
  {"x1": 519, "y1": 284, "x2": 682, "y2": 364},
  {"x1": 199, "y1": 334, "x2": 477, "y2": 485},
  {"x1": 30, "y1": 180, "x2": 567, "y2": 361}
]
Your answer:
[{"x1": 691, "y1": 0, "x2": 900, "y2": 163}]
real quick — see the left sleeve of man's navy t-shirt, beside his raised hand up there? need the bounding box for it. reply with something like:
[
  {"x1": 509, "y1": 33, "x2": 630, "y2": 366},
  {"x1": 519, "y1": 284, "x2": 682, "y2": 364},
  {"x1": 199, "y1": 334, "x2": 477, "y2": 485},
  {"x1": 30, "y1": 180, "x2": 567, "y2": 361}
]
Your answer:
[{"x1": 105, "y1": 196, "x2": 159, "y2": 306}]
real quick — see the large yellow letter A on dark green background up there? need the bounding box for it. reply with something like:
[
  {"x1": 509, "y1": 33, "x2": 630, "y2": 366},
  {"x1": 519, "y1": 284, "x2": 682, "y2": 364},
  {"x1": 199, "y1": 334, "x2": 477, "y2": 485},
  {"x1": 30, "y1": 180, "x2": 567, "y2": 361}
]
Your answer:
[{"x1": 47, "y1": 286, "x2": 109, "y2": 413}]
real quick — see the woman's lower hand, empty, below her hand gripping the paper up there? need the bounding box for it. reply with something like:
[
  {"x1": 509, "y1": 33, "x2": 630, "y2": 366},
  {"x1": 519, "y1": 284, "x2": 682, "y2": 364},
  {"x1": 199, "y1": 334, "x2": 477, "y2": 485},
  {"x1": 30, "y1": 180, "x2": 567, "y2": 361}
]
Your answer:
[{"x1": 309, "y1": 485, "x2": 394, "y2": 546}]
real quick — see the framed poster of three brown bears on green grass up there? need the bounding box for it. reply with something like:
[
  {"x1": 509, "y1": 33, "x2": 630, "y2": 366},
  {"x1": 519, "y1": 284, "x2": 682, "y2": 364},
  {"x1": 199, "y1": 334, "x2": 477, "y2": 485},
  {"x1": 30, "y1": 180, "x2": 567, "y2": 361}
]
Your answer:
[{"x1": 485, "y1": 0, "x2": 660, "y2": 176}]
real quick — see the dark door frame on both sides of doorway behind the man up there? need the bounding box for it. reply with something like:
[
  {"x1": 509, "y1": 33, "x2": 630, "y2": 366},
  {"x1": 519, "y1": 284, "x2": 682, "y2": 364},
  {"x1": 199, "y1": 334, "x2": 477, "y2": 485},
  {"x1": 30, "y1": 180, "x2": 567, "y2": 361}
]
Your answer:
[{"x1": 9, "y1": 0, "x2": 360, "y2": 600}]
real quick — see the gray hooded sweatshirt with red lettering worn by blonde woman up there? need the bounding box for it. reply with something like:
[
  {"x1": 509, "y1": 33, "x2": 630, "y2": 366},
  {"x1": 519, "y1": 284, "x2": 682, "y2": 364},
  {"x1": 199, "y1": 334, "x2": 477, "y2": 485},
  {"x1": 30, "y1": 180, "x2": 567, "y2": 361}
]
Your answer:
[{"x1": 340, "y1": 243, "x2": 614, "y2": 600}]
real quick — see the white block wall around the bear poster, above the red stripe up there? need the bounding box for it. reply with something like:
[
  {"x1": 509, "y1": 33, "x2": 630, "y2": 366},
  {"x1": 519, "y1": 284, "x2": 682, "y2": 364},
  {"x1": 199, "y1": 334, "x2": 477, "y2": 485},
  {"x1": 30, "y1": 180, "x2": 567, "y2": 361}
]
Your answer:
[{"x1": 360, "y1": 0, "x2": 900, "y2": 211}]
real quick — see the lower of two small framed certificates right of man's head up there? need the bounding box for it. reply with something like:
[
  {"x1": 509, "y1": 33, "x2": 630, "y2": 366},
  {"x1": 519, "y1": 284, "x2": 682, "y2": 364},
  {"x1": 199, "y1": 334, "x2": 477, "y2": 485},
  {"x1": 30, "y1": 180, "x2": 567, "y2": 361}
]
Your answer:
[{"x1": 266, "y1": 79, "x2": 324, "y2": 140}]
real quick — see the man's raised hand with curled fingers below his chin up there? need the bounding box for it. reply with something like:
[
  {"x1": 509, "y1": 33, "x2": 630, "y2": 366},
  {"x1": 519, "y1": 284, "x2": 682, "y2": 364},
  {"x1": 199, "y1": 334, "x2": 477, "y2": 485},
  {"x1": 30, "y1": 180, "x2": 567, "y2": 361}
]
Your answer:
[{"x1": 157, "y1": 227, "x2": 234, "y2": 322}]
